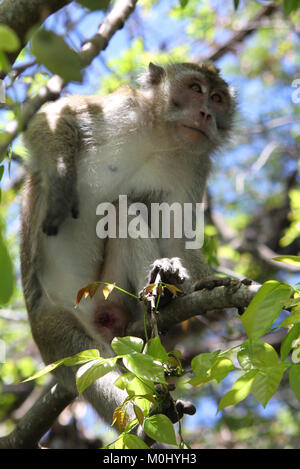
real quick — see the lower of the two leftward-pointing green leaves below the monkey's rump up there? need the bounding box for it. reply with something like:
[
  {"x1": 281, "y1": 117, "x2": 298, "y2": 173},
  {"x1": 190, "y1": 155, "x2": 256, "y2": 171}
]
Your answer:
[{"x1": 76, "y1": 357, "x2": 118, "y2": 394}]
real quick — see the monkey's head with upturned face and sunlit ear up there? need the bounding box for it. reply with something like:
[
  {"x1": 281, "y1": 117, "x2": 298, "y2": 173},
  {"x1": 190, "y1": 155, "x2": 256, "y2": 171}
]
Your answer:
[{"x1": 140, "y1": 63, "x2": 235, "y2": 151}]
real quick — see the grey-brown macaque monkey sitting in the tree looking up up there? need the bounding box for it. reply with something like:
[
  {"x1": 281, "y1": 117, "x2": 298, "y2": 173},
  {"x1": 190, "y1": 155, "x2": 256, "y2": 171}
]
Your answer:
[{"x1": 21, "y1": 63, "x2": 235, "y2": 432}]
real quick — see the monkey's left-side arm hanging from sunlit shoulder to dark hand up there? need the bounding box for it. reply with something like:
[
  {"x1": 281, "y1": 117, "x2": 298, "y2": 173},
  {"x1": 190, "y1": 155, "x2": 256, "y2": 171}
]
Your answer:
[{"x1": 24, "y1": 105, "x2": 80, "y2": 235}]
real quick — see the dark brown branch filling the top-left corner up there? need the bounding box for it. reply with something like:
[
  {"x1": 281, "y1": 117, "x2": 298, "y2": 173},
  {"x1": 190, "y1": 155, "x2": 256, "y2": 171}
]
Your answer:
[{"x1": 0, "y1": 0, "x2": 70, "y2": 79}]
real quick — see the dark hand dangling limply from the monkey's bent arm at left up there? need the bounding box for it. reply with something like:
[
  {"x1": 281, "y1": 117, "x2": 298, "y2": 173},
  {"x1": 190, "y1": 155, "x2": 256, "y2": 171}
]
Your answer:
[{"x1": 42, "y1": 181, "x2": 79, "y2": 236}]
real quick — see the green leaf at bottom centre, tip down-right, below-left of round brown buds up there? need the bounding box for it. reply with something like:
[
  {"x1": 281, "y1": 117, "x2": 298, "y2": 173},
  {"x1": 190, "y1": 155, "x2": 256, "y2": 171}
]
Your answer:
[{"x1": 144, "y1": 414, "x2": 177, "y2": 445}]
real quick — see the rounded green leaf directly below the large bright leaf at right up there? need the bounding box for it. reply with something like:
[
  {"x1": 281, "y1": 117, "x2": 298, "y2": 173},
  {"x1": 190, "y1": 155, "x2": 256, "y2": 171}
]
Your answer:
[{"x1": 237, "y1": 340, "x2": 278, "y2": 370}]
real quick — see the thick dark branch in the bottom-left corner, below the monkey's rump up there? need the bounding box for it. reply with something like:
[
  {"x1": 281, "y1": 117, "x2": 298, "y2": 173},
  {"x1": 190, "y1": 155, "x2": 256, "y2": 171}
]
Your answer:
[{"x1": 0, "y1": 384, "x2": 76, "y2": 449}]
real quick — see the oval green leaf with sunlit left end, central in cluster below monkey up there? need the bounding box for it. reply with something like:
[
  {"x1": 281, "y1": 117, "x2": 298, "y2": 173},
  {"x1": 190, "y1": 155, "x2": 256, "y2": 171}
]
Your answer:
[{"x1": 123, "y1": 352, "x2": 166, "y2": 384}]
